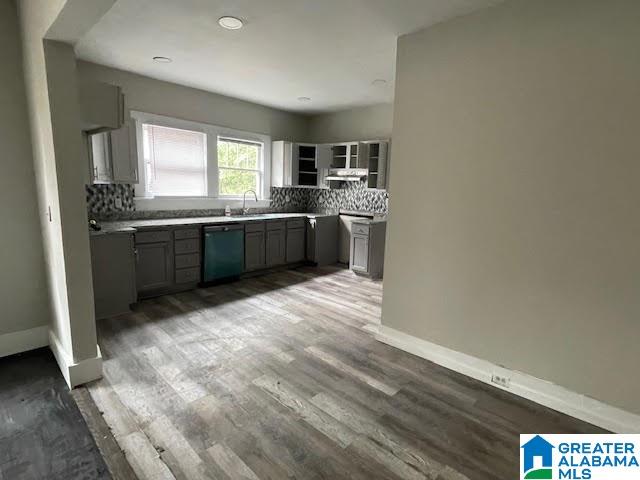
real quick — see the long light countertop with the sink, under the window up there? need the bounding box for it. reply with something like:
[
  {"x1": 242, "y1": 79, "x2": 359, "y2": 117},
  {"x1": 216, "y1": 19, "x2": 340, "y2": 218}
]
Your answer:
[{"x1": 90, "y1": 213, "x2": 335, "y2": 235}]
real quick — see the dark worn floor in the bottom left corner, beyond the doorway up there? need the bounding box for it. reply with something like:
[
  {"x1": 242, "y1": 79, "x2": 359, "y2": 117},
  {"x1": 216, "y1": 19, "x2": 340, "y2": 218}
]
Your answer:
[{"x1": 0, "y1": 348, "x2": 111, "y2": 480}]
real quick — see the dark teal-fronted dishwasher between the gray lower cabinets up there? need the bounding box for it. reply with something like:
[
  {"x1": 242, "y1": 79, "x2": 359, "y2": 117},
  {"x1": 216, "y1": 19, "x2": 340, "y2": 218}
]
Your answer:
[{"x1": 203, "y1": 223, "x2": 244, "y2": 283}]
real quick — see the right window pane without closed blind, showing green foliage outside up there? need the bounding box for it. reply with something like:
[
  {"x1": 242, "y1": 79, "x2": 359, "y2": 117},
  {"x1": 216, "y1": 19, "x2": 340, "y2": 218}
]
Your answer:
[{"x1": 218, "y1": 137, "x2": 263, "y2": 197}]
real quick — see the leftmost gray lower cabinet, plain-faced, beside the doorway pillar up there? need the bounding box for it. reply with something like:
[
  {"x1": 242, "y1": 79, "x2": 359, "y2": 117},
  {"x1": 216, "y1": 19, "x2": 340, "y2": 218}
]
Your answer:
[{"x1": 90, "y1": 233, "x2": 136, "y2": 319}]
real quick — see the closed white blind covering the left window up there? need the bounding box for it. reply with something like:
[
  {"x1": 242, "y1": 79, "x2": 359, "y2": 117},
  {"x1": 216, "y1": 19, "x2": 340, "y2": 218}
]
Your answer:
[{"x1": 142, "y1": 123, "x2": 207, "y2": 197}]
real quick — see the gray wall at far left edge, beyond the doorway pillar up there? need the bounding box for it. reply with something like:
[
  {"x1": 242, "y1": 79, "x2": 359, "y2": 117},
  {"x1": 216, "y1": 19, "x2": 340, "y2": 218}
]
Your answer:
[{"x1": 0, "y1": 0, "x2": 50, "y2": 335}]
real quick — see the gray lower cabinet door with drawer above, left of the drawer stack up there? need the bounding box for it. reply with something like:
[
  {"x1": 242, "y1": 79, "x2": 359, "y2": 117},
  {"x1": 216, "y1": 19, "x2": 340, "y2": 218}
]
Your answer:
[{"x1": 136, "y1": 230, "x2": 174, "y2": 297}]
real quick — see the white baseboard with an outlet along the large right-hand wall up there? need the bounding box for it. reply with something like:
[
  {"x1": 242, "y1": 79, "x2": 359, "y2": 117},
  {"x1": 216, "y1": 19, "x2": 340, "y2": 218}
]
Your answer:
[{"x1": 375, "y1": 325, "x2": 640, "y2": 433}]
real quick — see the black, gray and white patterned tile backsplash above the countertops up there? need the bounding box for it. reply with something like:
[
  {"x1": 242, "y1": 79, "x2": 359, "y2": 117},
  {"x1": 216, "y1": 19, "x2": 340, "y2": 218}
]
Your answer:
[{"x1": 86, "y1": 182, "x2": 389, "y2": 220}]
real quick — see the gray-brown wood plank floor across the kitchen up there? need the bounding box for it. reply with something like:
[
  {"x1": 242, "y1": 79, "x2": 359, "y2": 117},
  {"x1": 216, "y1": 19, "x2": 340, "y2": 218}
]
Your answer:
[{"x1": 89, "y1": 267, "x2": 599, "y2": 480}]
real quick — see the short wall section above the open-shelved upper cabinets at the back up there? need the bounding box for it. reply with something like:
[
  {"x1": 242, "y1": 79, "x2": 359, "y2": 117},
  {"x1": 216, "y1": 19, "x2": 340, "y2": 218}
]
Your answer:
[{"x1": 308, "y1": 104, "x2": 393, "y2": 143}]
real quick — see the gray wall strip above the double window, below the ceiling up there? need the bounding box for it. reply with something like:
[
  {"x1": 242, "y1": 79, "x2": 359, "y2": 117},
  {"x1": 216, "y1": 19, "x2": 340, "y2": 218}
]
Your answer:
[{"x1": 78, "y1": 62, "x2": 309, "y2": 140}]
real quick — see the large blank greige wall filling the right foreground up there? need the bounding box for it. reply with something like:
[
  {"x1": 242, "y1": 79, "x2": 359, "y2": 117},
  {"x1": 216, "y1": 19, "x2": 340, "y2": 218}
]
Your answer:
[{"x1": 383, "y1": 0, "x2": 640, "y2": 413}]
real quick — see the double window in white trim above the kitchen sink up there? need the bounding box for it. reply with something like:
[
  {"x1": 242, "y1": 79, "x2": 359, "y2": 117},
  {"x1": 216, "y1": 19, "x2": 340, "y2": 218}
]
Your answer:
[{"x1": 131, "y1": 112, "x2": 271, "y2": 210}]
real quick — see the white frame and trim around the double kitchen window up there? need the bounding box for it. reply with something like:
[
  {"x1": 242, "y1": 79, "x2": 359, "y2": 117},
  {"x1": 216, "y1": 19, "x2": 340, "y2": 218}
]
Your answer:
[{"x1": 131, "y1": 111, "x2": 271, "y2": 210}]
